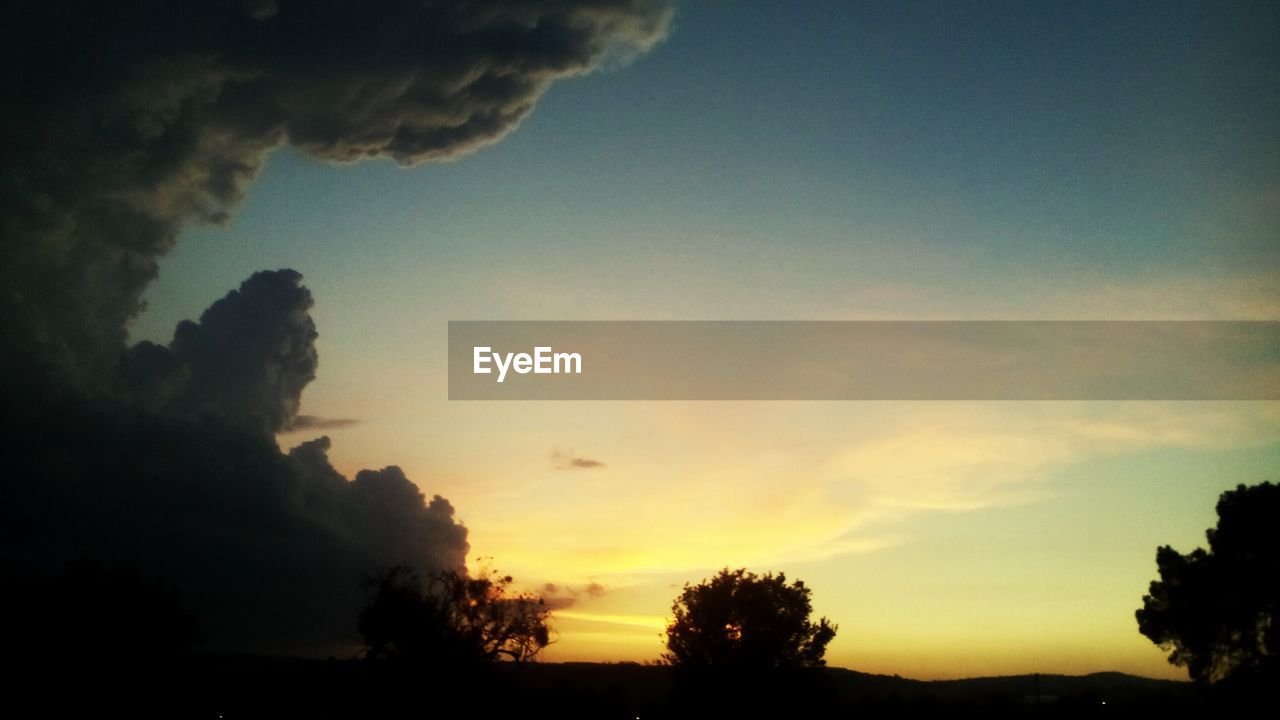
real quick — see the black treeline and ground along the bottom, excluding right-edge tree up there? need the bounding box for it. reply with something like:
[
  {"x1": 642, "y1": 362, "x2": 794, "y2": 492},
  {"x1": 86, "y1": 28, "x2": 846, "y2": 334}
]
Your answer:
[{"x1": 5, "y1": 545, "x2": 1256, "y2": 719}]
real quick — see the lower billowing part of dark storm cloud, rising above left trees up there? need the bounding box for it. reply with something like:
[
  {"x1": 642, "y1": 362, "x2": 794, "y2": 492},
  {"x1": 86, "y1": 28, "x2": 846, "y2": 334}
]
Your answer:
[{"x1": 0, "y1": 270, "x2": 468, "y2": 655}]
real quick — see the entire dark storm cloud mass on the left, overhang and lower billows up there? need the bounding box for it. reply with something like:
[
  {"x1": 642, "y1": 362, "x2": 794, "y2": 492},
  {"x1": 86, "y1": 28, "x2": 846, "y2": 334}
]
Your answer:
[{"x1": 0, "y1": 0, "x2": 669, "y2": 652}]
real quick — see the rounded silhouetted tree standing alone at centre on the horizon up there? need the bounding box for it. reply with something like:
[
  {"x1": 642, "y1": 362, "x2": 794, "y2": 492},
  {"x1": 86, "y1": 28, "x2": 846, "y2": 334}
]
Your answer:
[{"x1": 663, "y1": 568, "x2": 836, "y2": 670}]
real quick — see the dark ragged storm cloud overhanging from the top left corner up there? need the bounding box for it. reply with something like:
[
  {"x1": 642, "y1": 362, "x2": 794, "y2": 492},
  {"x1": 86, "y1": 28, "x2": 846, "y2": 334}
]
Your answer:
[{"x1": 0, "y1": 0, "x2": 669, "y2": 374}]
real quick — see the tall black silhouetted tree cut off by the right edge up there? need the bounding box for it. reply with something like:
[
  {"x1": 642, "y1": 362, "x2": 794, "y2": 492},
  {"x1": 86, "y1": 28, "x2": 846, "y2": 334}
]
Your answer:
[{"x1": 1137, "y1": 483, "x2": 1280, "y2": 682}]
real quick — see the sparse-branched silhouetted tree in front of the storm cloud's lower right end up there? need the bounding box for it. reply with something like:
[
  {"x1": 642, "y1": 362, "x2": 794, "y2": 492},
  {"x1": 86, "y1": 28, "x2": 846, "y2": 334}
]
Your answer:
[{"x1": 358, "y1": 565, "x2": 550, "y2": 664}]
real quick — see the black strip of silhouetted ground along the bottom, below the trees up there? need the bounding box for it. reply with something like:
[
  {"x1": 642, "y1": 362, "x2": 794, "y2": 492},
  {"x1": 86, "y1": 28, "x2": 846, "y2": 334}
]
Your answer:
[{"x1": 15, "y1": 656, "x2": 1231, "y2": 720}]
